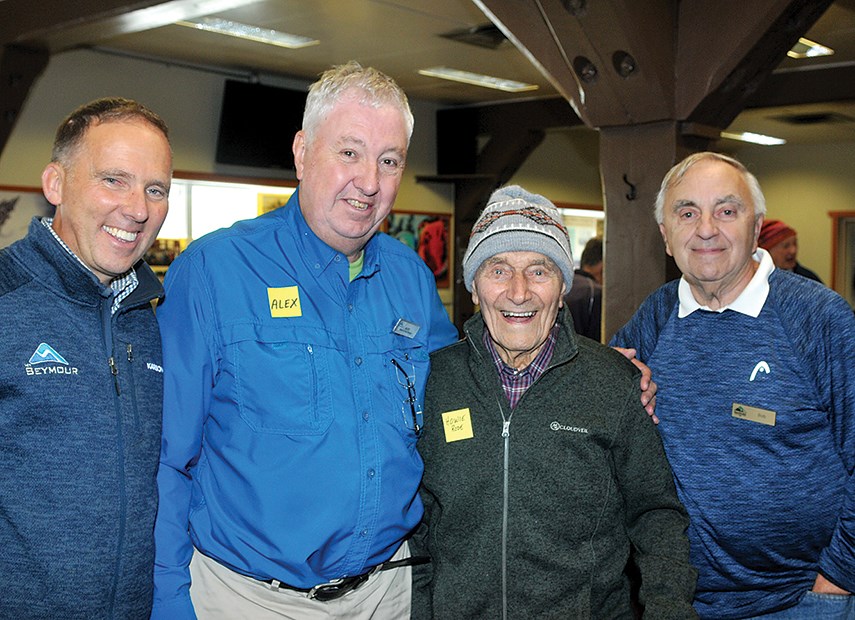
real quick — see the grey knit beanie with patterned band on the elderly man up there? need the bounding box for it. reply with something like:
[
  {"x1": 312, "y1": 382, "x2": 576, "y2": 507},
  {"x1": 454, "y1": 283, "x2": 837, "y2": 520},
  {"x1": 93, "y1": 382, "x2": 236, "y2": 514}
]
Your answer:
[{"x1": 463, "y1": 185, "x2": 573, "y2": 292}]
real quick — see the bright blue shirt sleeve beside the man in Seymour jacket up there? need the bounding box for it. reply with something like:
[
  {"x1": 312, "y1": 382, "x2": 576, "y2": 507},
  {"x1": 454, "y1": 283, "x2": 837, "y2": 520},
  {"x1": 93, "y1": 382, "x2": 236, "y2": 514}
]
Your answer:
[{"x1": 152, "y1": 256, "x2": 216, "y2": 620}]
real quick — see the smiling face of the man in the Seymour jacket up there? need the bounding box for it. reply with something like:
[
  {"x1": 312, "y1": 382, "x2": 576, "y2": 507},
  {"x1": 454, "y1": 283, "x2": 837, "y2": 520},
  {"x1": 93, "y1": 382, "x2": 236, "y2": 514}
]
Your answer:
[{"x1": 42, "y1": 119, "x2": 172, "y2": 284}]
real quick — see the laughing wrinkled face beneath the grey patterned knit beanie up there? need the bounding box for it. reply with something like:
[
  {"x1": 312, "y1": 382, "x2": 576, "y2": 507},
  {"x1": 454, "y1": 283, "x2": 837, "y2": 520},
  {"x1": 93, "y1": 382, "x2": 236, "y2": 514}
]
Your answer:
[{"x1": 472, "y1": 252, "x2": 565, "y2": 369}]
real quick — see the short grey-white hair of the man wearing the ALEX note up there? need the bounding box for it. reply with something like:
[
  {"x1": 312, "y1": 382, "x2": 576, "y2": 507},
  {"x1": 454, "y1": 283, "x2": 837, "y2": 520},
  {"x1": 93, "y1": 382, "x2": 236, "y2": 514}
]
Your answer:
[{"x1": 303, "y1": 60, "x2": 415, "y2": 144}]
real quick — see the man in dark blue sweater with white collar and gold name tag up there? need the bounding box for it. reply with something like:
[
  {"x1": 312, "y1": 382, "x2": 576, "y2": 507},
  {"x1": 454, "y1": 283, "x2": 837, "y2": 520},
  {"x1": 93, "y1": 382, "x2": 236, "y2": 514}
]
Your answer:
[{"x1": 612, "y1": 153, "x2": 855, "y2": 620}]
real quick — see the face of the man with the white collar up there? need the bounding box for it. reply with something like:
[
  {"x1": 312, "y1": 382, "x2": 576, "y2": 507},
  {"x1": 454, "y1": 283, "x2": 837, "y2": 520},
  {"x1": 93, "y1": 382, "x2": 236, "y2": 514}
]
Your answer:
[{"x1": 659, "y1": 160, "x2": 763, "y2": 309}]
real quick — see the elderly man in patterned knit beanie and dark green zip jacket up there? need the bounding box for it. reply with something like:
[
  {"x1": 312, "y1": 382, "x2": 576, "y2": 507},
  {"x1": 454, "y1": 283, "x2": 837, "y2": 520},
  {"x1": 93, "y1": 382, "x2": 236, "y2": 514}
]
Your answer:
[{"x1": 411, "y1": 186, "x2": 695, "y2": 618}]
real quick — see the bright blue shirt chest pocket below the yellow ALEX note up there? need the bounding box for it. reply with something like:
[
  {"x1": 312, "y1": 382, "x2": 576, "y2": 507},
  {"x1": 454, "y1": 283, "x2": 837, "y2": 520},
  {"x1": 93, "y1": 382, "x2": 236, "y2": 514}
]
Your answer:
[{"x1": 229, "y1": 326, "x2": 333, "y2": 435}]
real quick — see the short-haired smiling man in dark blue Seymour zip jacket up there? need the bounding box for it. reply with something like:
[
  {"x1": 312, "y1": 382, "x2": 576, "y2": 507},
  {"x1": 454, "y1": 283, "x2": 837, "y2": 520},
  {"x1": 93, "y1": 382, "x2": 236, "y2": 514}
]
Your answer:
[{"x1": 0, "y1": 98, "x2": 172, "y2": 620}]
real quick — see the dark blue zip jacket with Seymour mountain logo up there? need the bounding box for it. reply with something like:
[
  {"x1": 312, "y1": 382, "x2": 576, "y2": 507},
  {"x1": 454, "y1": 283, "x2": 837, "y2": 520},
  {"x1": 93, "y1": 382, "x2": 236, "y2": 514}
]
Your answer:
[{"x1": 0, "y1": 219, "x2": 163, "y2": 620}]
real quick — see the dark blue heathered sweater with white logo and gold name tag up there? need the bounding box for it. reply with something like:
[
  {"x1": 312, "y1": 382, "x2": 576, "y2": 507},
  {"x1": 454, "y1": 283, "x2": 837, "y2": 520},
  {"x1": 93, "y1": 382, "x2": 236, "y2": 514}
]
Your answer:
[{"x1": 612, "y1": 270, "x2": 855, "y2": 619}]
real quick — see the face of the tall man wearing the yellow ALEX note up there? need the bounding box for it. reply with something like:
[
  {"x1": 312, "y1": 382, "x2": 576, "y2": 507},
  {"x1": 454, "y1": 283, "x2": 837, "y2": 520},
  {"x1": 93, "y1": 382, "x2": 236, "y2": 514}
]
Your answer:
[{"x1": 294, "y1": 93, "x2": 408, "y2": 260}]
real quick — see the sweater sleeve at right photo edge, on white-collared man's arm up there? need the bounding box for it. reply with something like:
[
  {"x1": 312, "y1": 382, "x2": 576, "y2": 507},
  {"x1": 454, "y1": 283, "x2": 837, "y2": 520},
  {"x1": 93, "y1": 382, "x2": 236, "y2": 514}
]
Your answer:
[{"x1": 802, "y1": 295, "x2": 855, "y2": 594}]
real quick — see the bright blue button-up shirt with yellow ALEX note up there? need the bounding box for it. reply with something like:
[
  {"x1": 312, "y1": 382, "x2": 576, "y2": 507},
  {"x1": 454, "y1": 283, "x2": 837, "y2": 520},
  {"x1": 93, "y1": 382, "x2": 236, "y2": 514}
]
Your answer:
[{"x1": 154, "y1": 191, "x2": 457, "y2": 618}]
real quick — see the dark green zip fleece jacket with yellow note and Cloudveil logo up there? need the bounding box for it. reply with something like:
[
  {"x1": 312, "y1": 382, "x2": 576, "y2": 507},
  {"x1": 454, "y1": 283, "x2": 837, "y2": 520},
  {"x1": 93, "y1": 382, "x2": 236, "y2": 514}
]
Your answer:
[{"x1": 411, "y1": 309, "x2": 696, "y2": 620}]
